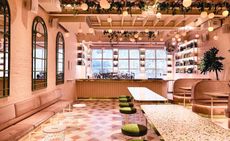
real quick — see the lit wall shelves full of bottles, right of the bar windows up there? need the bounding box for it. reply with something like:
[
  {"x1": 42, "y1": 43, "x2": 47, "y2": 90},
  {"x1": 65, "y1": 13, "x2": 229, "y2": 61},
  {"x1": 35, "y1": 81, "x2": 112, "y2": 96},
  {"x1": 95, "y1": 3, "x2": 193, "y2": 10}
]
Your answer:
[{"x1": 175, "y1": 40, "x2": 198, "y2": 74}]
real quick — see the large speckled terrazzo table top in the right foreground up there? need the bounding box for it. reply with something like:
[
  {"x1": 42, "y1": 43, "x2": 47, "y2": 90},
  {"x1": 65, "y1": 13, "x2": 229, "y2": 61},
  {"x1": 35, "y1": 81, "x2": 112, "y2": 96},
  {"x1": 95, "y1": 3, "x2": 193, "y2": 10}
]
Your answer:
[{"x1": 141, "y1": 105, "x2": 230, "y2": 141}]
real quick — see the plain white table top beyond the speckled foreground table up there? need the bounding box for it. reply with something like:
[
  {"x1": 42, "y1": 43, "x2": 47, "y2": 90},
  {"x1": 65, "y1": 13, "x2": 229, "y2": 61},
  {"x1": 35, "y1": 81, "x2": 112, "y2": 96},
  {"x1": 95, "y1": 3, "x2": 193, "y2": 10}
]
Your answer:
[{"x1": 128, "y1": 87, "x2": 167, "y2": 102}]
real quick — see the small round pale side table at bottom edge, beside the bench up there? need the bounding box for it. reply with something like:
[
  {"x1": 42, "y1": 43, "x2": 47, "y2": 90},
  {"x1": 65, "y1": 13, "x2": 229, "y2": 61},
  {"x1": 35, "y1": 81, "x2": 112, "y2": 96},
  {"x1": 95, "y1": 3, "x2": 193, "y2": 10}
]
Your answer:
[{"x1": 42, "y1": 125, "x2": 66, "y2": 141}]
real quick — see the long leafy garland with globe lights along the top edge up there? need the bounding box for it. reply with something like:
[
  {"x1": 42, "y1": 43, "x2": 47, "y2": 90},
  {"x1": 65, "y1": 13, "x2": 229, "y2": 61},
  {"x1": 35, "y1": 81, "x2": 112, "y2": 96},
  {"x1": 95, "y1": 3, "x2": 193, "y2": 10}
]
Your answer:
[{"x1": 60, "y1": 0, "x2": 230, "y2": 16}]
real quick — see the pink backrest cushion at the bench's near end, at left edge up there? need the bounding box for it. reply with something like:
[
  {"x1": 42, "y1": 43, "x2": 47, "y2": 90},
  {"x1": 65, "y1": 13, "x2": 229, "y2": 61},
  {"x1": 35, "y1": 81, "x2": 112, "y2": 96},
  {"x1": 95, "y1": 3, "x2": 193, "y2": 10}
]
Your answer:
[{"x1": 0, "y1": 104, "x2": 16, "y2": 125}]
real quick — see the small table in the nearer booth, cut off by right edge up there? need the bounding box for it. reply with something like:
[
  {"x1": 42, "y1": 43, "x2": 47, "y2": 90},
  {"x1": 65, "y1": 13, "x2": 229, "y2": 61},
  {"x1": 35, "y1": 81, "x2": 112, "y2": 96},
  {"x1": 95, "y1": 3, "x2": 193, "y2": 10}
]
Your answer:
[{"x1": 204, "y1": 92, "x2": 229, "y2": 120}]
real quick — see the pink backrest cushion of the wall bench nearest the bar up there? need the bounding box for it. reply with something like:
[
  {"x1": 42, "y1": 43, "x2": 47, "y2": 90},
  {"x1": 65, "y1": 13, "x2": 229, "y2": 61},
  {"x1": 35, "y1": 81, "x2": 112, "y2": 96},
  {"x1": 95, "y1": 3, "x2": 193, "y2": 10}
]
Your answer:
[{"x1": 40, "y1": 91, "x2": 60, "y2": 105}]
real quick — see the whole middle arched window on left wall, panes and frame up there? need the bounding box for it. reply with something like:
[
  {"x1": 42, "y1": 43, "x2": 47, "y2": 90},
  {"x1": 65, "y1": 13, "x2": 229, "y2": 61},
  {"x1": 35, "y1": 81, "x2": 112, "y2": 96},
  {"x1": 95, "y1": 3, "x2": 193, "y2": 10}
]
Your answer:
[{"x1": 32, "y1": 17, "x2": 48, "y2": 90}]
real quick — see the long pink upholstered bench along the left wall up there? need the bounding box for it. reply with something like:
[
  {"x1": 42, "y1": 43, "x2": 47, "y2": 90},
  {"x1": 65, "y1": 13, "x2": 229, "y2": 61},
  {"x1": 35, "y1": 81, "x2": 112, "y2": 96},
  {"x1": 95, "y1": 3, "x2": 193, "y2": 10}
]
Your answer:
[{"x1": 0, "y1": 89, "x2": 72, "y2": 141}]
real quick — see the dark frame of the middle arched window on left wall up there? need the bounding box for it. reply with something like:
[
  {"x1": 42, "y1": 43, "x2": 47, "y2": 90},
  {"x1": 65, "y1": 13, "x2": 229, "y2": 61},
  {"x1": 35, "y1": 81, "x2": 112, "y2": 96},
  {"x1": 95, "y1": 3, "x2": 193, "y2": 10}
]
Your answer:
[{"x1": 32, "y1": 16, "x2": 48, "y2": 91}]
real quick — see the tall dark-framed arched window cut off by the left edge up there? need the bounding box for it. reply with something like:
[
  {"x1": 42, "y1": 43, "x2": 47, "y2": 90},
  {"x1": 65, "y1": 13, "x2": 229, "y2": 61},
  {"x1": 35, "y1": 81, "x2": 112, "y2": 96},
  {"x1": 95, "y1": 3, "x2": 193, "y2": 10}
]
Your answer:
[{"x1": 0, "y1": 0, "x2": 10, "y2": 97}]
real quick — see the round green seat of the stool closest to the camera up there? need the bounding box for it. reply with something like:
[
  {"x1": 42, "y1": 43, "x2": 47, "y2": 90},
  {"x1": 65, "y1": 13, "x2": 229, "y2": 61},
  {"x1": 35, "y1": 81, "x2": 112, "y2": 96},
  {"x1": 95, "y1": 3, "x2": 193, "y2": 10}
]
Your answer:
[{"x1": 121, "y1": 124, "x2": 148, "y2": 137}]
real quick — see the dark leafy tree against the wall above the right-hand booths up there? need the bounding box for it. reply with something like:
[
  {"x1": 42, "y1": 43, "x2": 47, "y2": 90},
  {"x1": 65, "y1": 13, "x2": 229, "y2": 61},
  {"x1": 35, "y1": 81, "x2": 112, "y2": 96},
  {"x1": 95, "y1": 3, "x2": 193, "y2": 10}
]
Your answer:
[{"x1": 199, "y1": 47, "x2": 225, "y2": 80}]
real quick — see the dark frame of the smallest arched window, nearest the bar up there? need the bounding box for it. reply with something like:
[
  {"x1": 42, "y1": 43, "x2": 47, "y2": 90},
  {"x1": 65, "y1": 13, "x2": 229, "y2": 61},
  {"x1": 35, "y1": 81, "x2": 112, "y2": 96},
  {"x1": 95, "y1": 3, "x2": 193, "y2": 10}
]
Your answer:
[{"x1": 56, "y1": 32, "x2": 65, "y2": 85}]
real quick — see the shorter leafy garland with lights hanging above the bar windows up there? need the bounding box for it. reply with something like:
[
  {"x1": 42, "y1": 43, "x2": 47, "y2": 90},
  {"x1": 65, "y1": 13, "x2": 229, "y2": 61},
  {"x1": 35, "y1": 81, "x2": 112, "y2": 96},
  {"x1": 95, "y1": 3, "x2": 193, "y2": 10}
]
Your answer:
[{"x1": 103, "y1": 31, "x2": 158, "y2": 42}]
